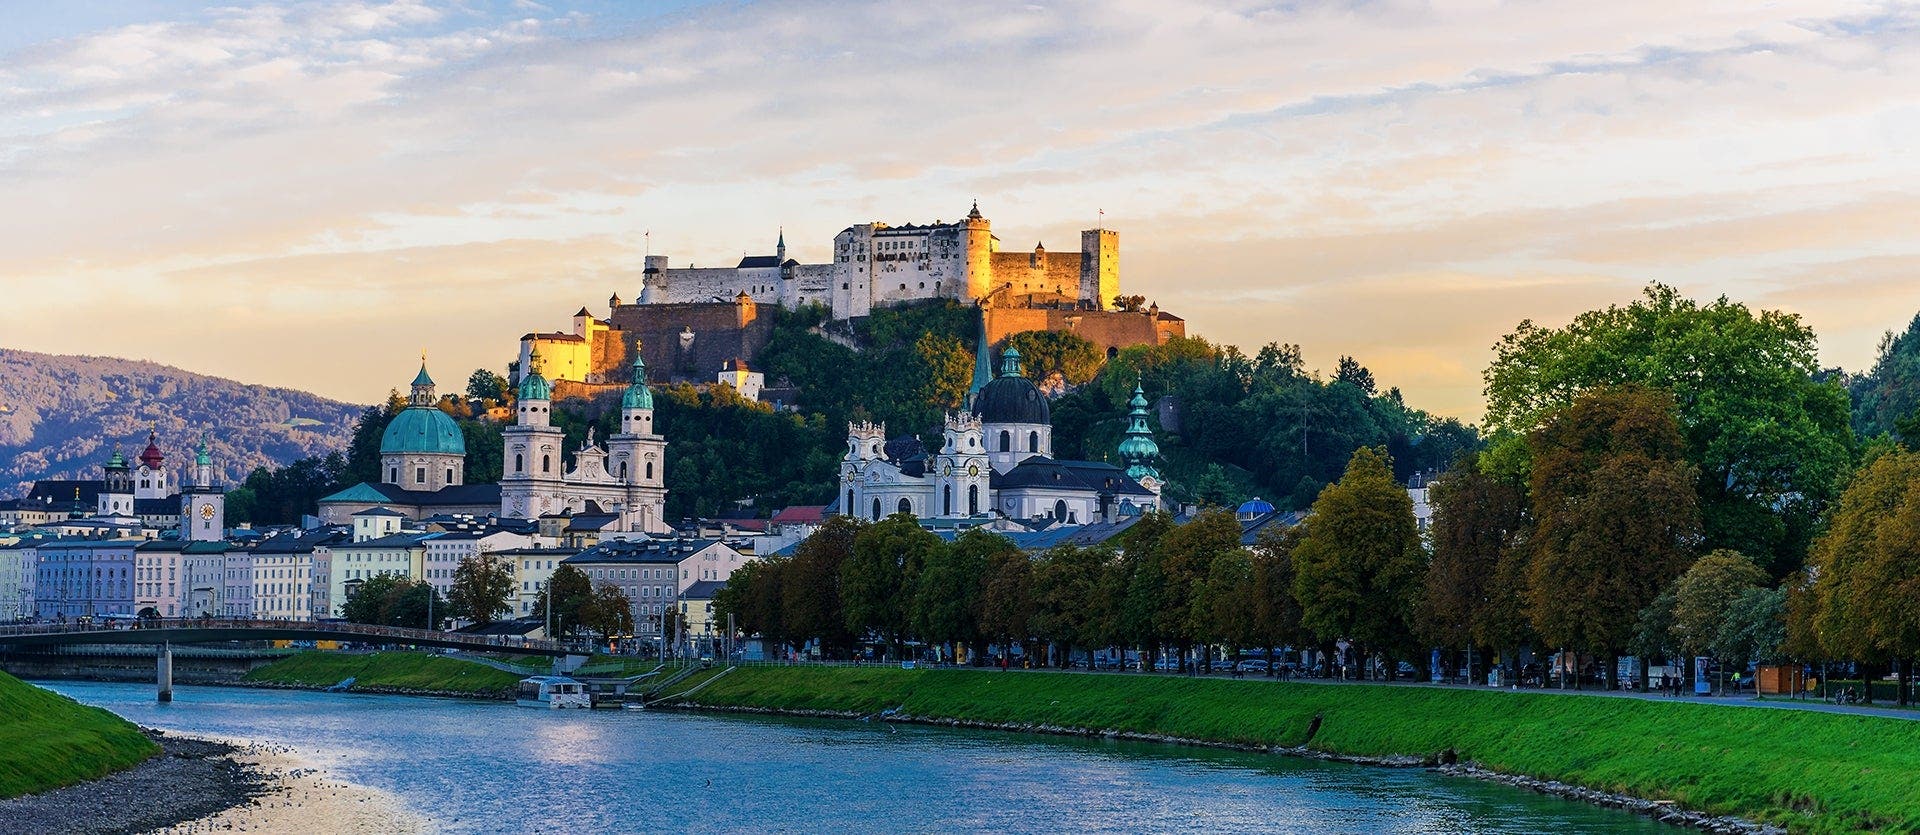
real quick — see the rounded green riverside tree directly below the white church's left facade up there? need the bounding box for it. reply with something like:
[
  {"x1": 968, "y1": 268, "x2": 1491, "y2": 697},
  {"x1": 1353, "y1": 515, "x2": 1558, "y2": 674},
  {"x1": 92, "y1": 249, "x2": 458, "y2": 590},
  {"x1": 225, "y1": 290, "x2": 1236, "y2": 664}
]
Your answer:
[{"x1": 839, "y1": 513, "x2": 947, "y2": 649}]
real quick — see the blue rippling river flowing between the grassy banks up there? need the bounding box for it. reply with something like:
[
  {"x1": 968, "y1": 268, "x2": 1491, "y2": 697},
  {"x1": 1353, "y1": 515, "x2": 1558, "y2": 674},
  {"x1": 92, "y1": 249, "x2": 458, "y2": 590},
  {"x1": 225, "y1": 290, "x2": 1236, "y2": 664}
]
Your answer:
[{"x1": 40, "y1": 681, "x2": 1672, "y2": 833}]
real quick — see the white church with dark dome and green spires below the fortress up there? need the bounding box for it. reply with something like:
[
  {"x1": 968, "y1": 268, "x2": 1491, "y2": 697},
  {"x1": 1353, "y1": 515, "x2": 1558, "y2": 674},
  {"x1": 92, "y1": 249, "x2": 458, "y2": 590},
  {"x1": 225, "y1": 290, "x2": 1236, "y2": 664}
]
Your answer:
[{"x1": 839, "y1": 328, "x2": 1162, "y2": 524}]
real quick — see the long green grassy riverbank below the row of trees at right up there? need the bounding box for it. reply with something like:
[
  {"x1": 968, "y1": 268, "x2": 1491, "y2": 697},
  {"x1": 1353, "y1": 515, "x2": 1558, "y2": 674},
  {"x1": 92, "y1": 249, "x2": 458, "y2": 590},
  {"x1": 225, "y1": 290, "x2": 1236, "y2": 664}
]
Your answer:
[{"x1": 689, "y1": 668, "x2": 1920, "y2": 833}]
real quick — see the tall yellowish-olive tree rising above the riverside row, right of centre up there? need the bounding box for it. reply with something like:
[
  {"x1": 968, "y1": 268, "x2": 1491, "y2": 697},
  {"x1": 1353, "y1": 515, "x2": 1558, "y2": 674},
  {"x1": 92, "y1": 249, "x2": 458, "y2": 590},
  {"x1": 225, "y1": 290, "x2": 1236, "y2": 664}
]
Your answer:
[{"x1": 1292, "y1": 447, "x2": 1427, "y2": 676}]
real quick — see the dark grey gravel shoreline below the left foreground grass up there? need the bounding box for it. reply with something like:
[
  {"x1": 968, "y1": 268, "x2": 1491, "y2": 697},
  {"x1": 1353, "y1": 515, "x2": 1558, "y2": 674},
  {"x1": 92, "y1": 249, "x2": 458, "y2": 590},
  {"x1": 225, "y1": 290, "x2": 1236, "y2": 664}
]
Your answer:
[{"x1": 0, "y1": 728, "x2": 267, "y2": 835}]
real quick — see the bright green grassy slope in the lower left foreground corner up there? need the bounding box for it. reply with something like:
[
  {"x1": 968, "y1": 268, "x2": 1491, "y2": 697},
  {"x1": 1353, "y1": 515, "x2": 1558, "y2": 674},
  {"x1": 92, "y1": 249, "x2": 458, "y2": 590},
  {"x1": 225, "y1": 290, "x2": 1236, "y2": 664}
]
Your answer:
[{"x1": 0, "y1": 672, "x2": 159, "y2": 797}]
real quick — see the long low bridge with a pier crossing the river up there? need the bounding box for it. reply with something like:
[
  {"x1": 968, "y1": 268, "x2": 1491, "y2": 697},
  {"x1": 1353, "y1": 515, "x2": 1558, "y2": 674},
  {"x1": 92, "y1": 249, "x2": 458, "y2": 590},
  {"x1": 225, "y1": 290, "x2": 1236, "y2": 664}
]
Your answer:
[{"x1": 0, "y1": 618, "x2": 584, "y2": 703}]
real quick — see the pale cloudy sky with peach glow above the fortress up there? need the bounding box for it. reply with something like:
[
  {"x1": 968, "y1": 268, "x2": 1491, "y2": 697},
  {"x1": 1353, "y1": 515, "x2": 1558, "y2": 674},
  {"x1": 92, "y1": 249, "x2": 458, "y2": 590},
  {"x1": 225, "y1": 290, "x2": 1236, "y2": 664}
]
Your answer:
[{"x1": 0, "y1": 0, "x2": 1920, "y2": 420}]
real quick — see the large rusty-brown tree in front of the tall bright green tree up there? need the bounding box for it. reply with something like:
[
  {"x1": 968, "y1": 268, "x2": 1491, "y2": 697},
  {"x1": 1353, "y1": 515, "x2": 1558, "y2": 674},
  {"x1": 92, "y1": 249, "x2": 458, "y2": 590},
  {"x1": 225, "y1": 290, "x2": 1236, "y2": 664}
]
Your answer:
[{"x1": 1526, "y1": 386, "x2": 1699, "y2": 687}]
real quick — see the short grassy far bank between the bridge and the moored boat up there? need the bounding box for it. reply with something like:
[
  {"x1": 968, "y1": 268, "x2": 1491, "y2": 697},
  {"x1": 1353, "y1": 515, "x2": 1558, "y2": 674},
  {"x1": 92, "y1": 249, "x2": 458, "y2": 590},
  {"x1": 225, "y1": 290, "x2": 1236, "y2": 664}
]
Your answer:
[{"x1": 246, "y1": 653, "x2": 526, "y2": 695}]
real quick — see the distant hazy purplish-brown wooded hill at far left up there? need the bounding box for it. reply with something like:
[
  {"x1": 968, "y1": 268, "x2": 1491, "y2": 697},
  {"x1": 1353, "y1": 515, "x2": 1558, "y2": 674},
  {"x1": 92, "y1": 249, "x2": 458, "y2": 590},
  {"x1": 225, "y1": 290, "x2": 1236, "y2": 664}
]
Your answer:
[{"x1": 0, "y1": 349, "x2": 361, "y2": 497}]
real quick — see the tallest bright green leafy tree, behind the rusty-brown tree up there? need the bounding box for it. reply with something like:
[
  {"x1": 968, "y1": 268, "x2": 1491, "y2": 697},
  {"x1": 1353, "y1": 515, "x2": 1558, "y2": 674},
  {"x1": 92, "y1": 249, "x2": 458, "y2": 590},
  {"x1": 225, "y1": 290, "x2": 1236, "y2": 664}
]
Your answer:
[{"x1": 1486, "y1": 284, "x2": 1853, "y2": 576}]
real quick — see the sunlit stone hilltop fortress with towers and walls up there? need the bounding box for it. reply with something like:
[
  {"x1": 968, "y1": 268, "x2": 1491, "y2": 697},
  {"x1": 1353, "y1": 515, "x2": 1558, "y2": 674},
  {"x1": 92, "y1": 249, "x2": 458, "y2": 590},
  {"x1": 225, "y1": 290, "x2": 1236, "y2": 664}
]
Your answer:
[{"x1": 518, "y1": 203, "x2": 1187, "y2": 397}]
